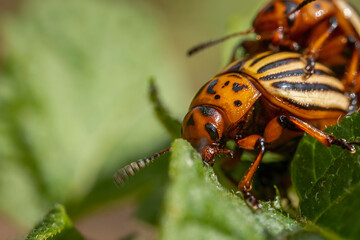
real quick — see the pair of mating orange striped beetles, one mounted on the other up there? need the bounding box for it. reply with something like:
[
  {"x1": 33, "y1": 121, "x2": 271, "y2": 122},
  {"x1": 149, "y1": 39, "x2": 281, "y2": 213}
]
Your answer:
[{"x1": 116, "y1": 0, "x2": 360, "y2": 206}]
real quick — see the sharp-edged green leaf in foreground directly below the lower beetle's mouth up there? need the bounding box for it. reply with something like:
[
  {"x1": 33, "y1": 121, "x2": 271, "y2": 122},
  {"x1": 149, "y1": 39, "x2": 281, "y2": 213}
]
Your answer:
[{"x1": 160, "y1": 139, "x2": 300, "y2": 239}]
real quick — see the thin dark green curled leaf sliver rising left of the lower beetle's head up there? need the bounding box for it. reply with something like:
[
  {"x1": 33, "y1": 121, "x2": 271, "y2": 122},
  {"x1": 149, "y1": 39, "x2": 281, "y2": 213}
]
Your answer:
[{"x1": 149, "y1": 78, "x2": 181, "y2": 139}]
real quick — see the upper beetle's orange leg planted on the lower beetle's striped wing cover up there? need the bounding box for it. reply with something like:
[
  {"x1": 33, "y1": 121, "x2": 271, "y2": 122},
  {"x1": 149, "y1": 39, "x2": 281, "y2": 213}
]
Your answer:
[{"x1": 304, "y1": 17, "x2": 338, "y2": 76}]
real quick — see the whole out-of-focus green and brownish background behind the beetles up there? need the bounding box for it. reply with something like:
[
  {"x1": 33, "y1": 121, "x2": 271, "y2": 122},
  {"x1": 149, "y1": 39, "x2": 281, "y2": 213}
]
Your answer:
[{"x1": 0, "y1": 0, "x2": 360, "y2": 239}]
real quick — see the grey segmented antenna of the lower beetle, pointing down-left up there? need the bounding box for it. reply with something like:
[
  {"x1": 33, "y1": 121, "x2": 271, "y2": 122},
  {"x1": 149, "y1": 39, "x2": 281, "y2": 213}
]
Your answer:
[{"x1": 114, "y1": 147, "x2": 171, "y2": 186}]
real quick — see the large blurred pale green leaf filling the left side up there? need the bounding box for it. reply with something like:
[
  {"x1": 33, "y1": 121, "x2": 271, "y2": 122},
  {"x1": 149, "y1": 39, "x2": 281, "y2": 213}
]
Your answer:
[{"x1": 0, "y1": 0, "x2": 186, "y2": 227}]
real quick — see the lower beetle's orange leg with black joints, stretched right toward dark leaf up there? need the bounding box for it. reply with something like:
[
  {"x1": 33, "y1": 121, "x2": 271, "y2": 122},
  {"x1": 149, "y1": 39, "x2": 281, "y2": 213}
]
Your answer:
[{"x1": 278, "y1": 115, "x2": 356, "y2": 153}]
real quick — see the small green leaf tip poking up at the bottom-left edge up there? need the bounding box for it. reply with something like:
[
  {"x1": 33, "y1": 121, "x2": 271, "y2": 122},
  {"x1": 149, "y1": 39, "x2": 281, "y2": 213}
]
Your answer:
[{"x1": 26, "y1": 204, "x2": 83, "y2": 240}]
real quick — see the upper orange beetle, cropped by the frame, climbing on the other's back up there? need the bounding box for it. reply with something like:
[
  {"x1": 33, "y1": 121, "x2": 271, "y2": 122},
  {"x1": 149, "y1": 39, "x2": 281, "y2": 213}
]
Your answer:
[{"x1": 188, "y1": 0, "x2": 360, "y2": 92}]
